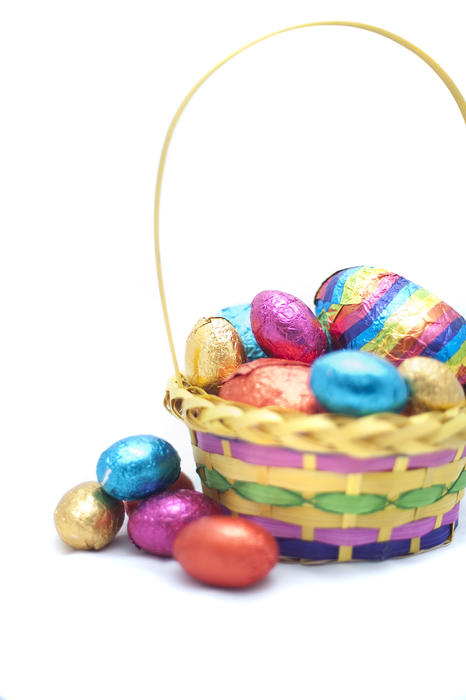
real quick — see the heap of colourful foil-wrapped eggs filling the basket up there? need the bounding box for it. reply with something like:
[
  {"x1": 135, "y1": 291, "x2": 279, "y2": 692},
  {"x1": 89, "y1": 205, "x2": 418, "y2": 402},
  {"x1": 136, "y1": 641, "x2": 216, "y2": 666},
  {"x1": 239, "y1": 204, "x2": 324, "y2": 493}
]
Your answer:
[{"x1": 185, "y1": 266, "x2": 466, "y2": 416}]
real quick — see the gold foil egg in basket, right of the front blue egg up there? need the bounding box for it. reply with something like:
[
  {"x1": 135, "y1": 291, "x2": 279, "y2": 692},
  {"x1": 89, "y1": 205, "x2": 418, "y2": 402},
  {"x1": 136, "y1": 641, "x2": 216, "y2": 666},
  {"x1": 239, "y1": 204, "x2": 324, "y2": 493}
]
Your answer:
[{"x1": 398, "y1": 357, "x2": 465, "y2": 413}]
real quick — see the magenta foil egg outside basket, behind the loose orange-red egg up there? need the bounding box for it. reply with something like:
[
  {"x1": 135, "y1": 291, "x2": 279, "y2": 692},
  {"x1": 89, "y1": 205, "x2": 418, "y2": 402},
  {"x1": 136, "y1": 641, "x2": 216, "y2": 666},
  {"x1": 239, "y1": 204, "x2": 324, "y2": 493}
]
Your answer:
[{"x1": 128, "y1": 489, "x2": 222, "y2": 557}]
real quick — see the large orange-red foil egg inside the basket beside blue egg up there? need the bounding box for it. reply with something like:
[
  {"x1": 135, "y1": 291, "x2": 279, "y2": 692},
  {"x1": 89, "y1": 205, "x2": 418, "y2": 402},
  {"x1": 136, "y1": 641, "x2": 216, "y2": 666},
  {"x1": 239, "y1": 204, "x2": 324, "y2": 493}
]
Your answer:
[{"x1": 219, "y1": 358, "x2": 323, "y2": 413}]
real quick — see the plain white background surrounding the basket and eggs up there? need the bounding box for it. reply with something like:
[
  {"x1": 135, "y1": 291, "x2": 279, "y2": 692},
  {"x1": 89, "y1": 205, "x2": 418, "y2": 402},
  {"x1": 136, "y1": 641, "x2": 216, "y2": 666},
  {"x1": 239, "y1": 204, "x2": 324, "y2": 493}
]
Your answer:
[{"x1": 0, "y1": 0, "x2": 466, "y2": 700}]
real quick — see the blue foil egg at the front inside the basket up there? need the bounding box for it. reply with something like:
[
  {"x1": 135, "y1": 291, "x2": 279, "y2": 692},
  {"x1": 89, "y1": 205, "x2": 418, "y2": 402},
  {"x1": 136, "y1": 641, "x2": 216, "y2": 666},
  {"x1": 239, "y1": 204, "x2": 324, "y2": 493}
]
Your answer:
[{"x1": 310, "y1": 350, "x2": 409, "y2": 416}]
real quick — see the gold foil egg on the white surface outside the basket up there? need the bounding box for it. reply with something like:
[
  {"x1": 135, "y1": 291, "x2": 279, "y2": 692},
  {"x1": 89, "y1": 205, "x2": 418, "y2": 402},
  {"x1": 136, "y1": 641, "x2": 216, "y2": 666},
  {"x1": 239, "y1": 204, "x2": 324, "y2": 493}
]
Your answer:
[{"x1": 55, "y1": 481, "x2": 125, "y2": 549}]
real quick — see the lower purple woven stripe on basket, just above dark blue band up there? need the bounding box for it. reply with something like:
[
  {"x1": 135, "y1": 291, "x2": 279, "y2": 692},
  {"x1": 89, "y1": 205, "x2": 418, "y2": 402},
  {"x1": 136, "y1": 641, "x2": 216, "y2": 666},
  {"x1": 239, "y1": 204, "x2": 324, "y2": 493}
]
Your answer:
[{"x1": 226, "y1": 503, "x2": 460, "y2": 547}]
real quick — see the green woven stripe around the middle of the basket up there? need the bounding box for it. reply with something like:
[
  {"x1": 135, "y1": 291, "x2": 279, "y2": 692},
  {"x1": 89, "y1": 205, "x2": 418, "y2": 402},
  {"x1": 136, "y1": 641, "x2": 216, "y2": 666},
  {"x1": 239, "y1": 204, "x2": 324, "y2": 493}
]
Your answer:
[{"x1": 197, "y1": 464, "x2": 466, "y2": 515}]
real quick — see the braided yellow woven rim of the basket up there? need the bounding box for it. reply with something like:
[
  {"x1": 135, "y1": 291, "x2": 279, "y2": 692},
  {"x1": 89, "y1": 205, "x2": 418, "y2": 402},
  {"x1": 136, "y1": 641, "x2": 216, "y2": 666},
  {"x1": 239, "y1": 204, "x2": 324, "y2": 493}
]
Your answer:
[{"x1": 164, "y1": 377, "x2": 466, "y2": 457}]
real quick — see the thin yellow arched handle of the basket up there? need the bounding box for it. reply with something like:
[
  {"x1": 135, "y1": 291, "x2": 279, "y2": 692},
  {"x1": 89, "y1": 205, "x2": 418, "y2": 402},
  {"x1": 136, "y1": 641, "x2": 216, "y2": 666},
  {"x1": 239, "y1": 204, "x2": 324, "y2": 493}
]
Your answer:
[{"x1": 154, "y1": 22, "x2": 466, "y2": 387}]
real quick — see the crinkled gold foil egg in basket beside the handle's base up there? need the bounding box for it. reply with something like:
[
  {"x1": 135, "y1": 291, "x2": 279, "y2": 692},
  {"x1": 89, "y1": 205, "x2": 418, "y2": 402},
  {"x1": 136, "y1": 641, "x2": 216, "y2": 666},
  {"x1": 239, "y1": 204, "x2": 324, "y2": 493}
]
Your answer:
[{"x1": 185, "y1": 316, "x2": 246, "y2": 392}]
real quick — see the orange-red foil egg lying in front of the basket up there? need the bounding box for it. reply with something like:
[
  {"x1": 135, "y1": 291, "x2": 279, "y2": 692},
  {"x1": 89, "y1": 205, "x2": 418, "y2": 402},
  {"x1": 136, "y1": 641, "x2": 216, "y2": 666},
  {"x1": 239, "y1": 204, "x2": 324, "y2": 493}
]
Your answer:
[{"x1": 173, "y1": 515, "x2": 278, "y2": 588}]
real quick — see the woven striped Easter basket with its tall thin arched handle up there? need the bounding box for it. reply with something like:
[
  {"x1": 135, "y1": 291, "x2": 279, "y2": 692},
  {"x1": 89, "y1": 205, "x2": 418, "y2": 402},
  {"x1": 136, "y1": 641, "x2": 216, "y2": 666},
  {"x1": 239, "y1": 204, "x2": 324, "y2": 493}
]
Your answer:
[{"x1": 155, "y1": 22, "x2": 466, "y2": 563}]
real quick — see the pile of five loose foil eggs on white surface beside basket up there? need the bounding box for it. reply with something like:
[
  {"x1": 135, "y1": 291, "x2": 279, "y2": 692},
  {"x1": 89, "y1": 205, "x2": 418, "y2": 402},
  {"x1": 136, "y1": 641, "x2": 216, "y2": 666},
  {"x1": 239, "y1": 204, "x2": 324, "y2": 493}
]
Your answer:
[{"x1": 55, "y1": 435, "x2": 278, "y2": 588}]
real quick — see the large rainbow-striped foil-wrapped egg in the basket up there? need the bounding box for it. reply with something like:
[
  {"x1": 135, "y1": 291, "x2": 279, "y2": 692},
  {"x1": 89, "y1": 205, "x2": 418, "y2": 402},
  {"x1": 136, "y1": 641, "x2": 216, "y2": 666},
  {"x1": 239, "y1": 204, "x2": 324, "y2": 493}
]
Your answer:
[{"x1": 315, "y1": 266, "x2": 466, "y2": 384}]
